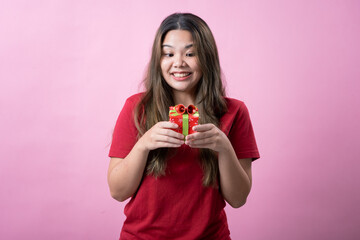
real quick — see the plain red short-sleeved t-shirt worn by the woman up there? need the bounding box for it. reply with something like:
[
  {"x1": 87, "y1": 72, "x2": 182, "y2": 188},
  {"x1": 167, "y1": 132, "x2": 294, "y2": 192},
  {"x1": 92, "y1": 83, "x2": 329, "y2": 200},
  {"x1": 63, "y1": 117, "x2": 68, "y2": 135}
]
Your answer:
[{"x1": 109, "y1": 93, "x2": 260, "y2": 240}]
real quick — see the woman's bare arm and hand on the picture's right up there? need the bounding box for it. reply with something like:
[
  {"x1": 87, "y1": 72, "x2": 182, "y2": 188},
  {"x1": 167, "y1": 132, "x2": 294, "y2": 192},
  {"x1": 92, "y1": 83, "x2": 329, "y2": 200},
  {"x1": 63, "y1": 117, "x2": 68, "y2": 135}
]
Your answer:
[{"x1": 185, "y1": 124, "x2": 252, "y2": 208}]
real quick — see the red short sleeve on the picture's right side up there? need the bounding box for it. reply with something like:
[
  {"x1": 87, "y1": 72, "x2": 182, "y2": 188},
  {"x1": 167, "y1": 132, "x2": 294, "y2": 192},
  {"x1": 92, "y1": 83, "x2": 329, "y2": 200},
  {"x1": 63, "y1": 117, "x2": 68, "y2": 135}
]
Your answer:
[{"x1": 225, "y1": 99, "x2": 260, "y2": 161}]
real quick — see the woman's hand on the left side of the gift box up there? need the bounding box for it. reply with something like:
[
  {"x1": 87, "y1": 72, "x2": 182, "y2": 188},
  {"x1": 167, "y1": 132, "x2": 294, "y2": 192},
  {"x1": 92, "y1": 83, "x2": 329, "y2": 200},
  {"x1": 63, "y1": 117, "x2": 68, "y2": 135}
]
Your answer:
[{"x1": 139, "y1": 121, "x2": 185, "y2": 151}]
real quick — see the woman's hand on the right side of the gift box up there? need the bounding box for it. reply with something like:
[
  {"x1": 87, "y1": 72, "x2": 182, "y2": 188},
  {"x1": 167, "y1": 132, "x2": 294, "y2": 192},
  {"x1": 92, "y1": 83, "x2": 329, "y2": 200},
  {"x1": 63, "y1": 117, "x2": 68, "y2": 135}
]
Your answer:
[{"x1": 185, "y1": 123, "x2": 231, "y2": 152}]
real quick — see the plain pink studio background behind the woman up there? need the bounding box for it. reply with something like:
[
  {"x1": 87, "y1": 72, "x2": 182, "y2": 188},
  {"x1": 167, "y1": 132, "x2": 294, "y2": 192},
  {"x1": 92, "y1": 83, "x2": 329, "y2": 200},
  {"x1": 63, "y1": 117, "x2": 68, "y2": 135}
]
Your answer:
[{"x1": 0, "y1": 0, "x2": 360, "y2": 240}]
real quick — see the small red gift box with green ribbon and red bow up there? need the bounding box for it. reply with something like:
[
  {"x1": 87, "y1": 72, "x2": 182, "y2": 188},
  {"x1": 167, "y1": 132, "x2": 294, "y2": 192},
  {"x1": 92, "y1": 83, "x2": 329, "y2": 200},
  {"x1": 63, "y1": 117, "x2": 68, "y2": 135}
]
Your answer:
[{"x1": 169, "y1": 104, "x2": 199, "y2": 136}]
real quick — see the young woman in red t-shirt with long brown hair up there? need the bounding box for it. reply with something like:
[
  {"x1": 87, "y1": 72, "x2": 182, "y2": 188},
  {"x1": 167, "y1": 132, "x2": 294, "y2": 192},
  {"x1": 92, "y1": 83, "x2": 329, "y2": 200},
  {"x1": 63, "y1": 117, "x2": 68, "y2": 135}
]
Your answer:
[{"x1": 108, "y1": 13, "x2": 260, "y2": 240}]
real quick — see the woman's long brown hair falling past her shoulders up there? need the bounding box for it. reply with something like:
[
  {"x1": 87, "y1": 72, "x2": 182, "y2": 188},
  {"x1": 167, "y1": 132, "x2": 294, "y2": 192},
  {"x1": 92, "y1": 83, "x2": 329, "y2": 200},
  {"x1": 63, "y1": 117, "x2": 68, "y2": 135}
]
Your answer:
[{"x1": 134, "y1": 13, "x2": 227, "y2": 186}]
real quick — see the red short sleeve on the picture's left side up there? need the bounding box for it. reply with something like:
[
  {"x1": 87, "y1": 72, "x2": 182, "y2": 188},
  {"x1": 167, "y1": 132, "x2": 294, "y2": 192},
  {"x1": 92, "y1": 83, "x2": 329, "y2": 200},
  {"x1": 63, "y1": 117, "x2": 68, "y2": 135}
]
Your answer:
[{"x1": 109, "y1": 94, "x2": 138, "y2": 158}]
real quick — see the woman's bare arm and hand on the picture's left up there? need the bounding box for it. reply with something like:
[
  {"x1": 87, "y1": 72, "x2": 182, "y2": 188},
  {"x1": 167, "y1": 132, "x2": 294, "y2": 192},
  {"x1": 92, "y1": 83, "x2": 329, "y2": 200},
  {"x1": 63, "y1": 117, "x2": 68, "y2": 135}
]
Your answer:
[{"x1": 108, "y1": 122, "x2": 184, "y2": 201}]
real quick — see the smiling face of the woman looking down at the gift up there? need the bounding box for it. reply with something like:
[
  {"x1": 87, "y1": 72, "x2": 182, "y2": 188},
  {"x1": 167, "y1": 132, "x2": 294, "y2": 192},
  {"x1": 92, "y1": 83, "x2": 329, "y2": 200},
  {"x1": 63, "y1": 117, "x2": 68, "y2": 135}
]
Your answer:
[{"x1": 160, "y1": 30, "x2": 202, "y2": 99}]
